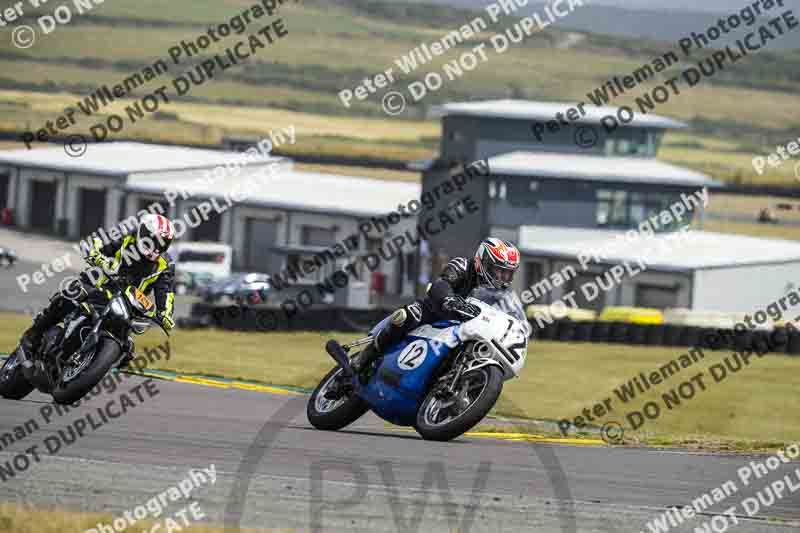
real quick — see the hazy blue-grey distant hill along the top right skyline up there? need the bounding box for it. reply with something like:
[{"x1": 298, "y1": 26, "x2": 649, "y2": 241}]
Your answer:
[{"x1": 391, "y1": 0, "x2": 800, "y2": 51}]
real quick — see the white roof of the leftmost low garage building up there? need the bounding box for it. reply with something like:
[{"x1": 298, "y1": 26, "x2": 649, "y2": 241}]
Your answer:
[{"x1": 0, "y1": 142, "x2": 274, "y2": 177}]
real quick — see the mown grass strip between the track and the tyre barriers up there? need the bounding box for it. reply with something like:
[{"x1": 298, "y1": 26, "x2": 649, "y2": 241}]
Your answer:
[{"x1": 0, "y1": 314, "x2": 800, "y2": 447}]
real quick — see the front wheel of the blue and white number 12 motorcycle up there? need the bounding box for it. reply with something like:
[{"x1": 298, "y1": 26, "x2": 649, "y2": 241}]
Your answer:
[{"x1": 416, "y1": 366, "x2": 503, "y2": 441}]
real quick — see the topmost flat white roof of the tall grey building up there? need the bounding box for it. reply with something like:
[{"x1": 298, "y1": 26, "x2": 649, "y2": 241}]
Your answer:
[{"x1": 430, "y1": 99, "x2": 687, "y2": 129}]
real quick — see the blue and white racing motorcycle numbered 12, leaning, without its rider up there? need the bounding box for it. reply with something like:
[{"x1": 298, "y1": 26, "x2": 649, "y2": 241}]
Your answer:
[{"x1": 307, "y1": 287, "x2": 531, "y2": 441}]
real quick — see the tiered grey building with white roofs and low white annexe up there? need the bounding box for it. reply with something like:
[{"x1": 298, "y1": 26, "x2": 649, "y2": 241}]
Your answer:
[{"x1": 422, "y1": 100, "x2": 800, "y2": 312}]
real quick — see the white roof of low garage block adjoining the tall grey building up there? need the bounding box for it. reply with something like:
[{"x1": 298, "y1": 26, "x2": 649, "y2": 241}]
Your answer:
[{"x1": 126, "y1": 165, "x2": 421, "y2": 217}]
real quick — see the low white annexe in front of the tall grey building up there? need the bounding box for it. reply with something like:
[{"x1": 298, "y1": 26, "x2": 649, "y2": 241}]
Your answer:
[{"x1": 518, "y1": 226, "x2": 800, "y2": 313}]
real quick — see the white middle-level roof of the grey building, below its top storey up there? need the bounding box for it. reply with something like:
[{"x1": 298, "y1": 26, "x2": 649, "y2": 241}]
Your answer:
[{"x1": 489, "y1": 152, "x2": 722, "y2": 187}]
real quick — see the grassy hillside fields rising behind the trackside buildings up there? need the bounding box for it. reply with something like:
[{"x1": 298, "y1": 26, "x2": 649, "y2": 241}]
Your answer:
[{"x1": 0, "y1": 0, "x2": 800, "y2": 186}]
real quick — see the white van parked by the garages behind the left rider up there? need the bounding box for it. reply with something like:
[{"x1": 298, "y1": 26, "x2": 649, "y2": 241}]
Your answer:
[{"x1": 170, "y1": 242, "x2": 233, "y2": 294}]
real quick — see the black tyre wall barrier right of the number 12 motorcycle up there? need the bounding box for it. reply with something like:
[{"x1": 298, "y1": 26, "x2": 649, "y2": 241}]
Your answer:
[{"x1": 531, "y1": 319, "x2": 800, "y2": 355}]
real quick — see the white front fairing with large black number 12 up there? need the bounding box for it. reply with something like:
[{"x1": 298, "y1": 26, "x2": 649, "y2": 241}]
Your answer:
[{"x1": 457, "y1": 298, "x2": 528, "y2": 379}]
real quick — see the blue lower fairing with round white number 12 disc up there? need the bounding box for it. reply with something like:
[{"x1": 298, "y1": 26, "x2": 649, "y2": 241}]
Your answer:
[{"x1": 359, "y1": 321, "x2": 458, "y2": 426}]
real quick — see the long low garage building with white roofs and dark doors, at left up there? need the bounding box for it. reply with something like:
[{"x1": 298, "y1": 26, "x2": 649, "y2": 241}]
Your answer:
[{"x1": 0, "y1": 142, "x2": 420, "y2": 304}]
